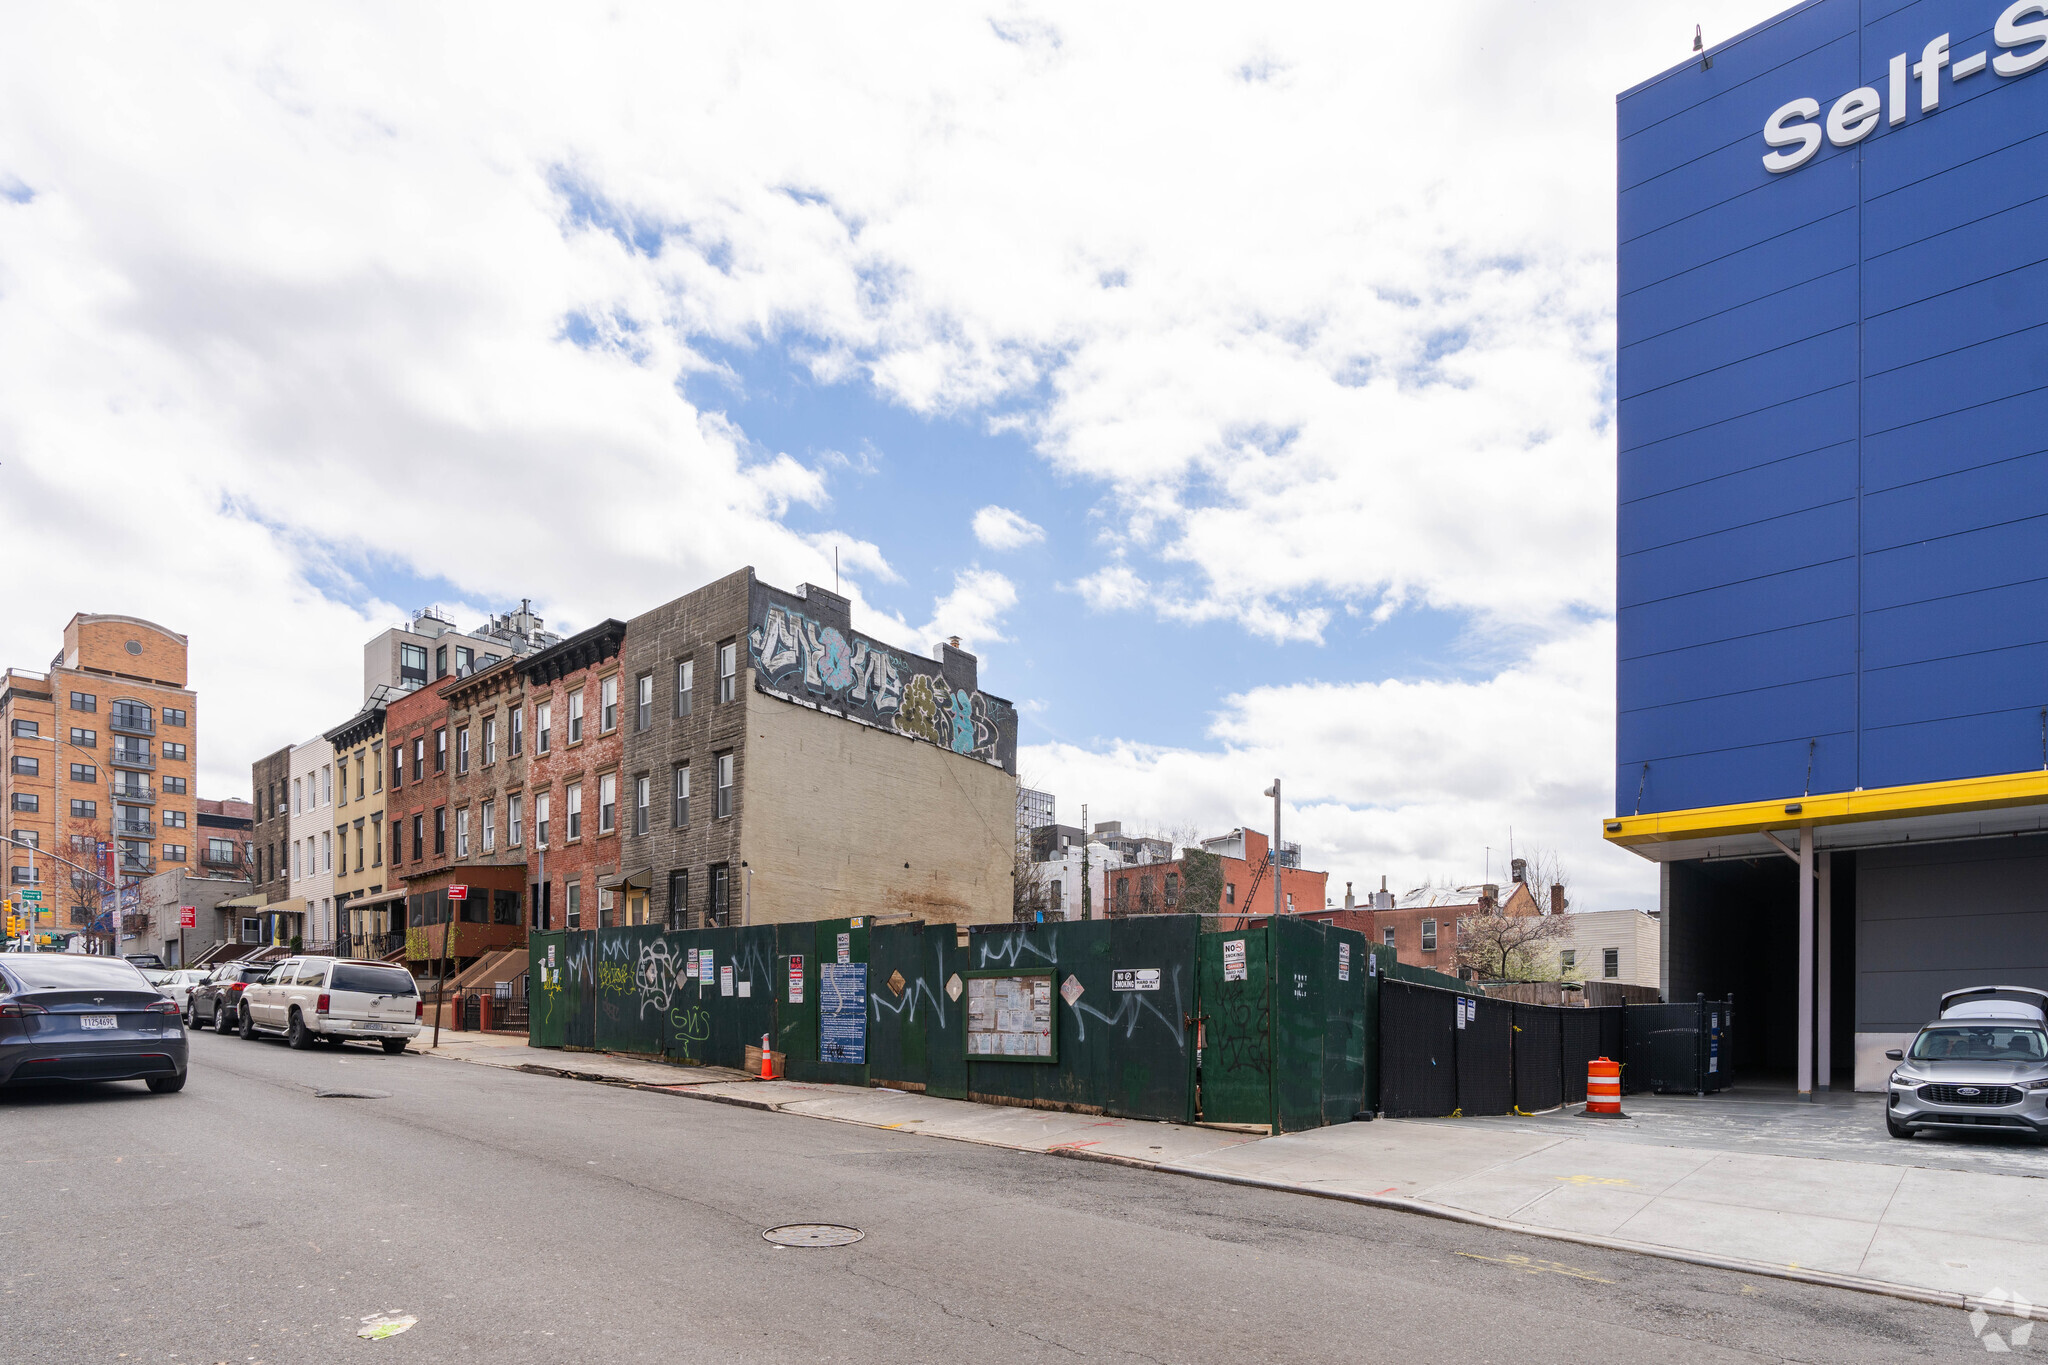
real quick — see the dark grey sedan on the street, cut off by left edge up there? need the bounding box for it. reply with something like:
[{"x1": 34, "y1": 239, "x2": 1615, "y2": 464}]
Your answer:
[{"x1": 0, "y1": 954, "x2": 186, "y2": 1095}]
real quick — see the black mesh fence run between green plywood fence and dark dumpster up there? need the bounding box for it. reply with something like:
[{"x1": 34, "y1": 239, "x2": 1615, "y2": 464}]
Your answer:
[{"x1": 1378, "y1": 976, "x2": 1632, "y2": 1117}]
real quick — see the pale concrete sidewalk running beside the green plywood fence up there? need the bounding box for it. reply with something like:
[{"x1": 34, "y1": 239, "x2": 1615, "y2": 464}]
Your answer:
[{"x1": 430, "y1": 1033, "x2": 2048, "y2": 1304}]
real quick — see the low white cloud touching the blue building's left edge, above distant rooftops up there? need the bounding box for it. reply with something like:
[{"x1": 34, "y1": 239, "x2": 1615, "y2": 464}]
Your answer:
[{"x1": 1018, "y1": 622, "x2": 1657, "y2": 909}]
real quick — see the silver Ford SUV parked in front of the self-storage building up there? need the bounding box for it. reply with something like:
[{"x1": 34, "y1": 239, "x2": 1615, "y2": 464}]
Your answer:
[{"x1": 1884, "y1": 986, "x2": 2048, "y2": 1138}]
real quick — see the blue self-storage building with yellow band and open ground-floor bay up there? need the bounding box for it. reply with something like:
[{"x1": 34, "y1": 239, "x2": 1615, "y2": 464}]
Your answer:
[{"x1": 1606, "y1": 0, "x2": 2048, "y2": 1089}]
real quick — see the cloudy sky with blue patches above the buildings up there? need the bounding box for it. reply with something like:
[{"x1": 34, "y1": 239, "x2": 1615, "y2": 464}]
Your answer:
[{"x1": 0, "y1": 0, "x2": 1778, "y2": 909}]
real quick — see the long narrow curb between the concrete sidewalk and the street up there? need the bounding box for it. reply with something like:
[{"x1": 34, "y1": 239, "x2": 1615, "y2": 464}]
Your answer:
[{"x1": 442, "y1": 1058, "x2": 2015, "y2": 1318}]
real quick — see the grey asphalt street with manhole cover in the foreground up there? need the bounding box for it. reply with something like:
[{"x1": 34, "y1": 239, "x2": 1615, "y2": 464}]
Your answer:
[{"x1": 0, "y1": 1033, "x2": 2011, "y2": 1365}]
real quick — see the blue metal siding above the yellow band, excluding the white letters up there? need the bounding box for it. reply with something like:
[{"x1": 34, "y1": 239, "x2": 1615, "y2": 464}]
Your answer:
[{"x1": 1616, "y1": 0, "x2": 2048, "y2": 812}]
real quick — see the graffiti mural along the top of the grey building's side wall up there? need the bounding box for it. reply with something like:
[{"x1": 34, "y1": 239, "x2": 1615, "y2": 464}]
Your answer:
[{"x1": 748, "y1": 604, "x2": 1016, "y2": 769}]
